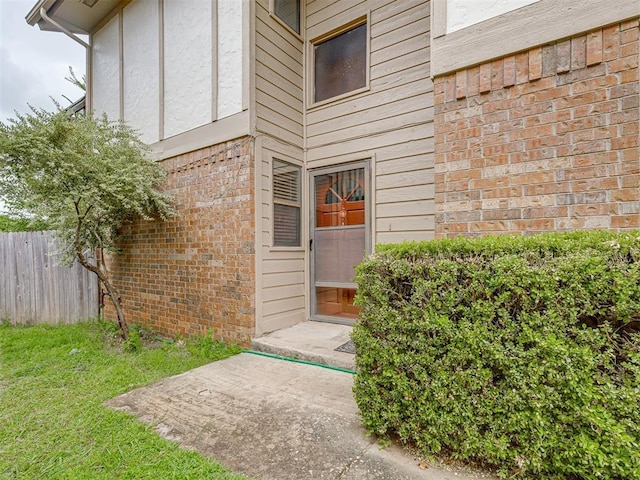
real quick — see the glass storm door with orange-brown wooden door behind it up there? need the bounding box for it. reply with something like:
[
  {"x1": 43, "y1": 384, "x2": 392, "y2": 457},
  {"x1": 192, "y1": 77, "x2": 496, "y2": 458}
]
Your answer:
[{"x1": 311, "y1": 163, "x2": 369, "y2": 323}]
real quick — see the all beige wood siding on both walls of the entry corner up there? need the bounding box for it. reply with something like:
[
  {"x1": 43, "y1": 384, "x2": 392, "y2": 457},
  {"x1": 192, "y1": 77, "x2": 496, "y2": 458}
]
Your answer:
[{"x1": 253, "y1": 0, "x2": 434, "y2": 336}]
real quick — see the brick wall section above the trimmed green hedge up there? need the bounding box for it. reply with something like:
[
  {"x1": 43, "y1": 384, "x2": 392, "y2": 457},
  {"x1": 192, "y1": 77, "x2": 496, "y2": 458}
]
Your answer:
[{"x1": 434, "y1": 19, "x2": 640, "y2": 238}]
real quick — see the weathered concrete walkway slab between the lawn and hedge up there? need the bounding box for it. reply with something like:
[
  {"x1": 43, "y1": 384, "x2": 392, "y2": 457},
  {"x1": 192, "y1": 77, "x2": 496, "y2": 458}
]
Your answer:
[{"x1": 107, "y1": 344, "x2": 496, "y2": 480}]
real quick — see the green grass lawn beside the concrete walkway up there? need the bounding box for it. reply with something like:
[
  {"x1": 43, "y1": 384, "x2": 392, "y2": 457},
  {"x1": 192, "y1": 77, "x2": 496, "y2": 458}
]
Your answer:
[{"x1": 0, "y1": 323, "x2": 244, "y2": 480}]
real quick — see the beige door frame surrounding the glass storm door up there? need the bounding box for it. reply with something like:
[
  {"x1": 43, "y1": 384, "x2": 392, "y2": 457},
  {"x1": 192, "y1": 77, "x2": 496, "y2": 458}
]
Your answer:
[{"x1": 307, "y1": 159, "x2": 373, "y2": 325}]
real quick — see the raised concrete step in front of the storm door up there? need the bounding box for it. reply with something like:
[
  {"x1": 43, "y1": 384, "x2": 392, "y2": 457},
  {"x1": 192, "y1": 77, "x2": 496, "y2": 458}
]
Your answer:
[{"x1": 251, "y1": 322, "x2": 355, "y2": 370}]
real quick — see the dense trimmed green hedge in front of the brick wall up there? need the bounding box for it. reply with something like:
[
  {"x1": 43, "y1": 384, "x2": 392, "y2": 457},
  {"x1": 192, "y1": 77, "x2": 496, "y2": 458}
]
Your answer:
[{"x1": 352, "y1": 232, "x2": 640, "y2": 479}]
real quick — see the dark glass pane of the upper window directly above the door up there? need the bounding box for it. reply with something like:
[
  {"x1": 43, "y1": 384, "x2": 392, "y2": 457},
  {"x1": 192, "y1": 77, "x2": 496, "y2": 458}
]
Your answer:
[{"x1": 313, "y1": 23, "x2": 367, "y2": 102}]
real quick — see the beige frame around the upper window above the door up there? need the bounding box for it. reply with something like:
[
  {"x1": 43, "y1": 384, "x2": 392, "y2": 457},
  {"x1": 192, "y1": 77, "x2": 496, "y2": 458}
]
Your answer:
[{"x1": 307, "y1": 12, "x2": 371, "y2": 109}]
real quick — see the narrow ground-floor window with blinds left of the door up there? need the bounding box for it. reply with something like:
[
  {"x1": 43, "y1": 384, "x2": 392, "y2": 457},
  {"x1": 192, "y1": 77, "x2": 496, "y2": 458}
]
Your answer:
[{"x1": 273, "y1": 158, "x2": 301, "y2": 247}]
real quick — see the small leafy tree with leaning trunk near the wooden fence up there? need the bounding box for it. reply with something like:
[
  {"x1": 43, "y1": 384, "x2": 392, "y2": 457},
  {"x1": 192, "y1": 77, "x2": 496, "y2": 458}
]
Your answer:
[{"x1": 0, "y1": 108, "x2": 173, "y2": 339}]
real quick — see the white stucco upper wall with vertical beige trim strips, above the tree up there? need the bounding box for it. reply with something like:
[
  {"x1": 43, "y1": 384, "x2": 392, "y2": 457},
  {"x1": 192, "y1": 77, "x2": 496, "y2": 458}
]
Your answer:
[{"x1": 90, "y1": 0, "x2": 249, "y2": 144}]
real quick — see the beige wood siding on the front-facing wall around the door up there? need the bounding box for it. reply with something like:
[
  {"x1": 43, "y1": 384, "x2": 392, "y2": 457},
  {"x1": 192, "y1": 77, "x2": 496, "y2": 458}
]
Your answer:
[{"x1": 306, "y1": 0, "x2": 435, "y2": 243}]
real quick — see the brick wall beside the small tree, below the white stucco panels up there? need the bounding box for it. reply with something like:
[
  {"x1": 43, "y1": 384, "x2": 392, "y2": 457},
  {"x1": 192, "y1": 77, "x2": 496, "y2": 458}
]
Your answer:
[{"x1": 106, "y1": 137, "x2": 255, "y2": 345}]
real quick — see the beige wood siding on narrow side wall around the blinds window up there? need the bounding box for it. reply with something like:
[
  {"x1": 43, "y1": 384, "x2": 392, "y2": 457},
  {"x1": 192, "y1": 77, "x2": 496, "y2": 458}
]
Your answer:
[{"x1": 254, "y1": 0, "x2": 307, "y2": 336}]
